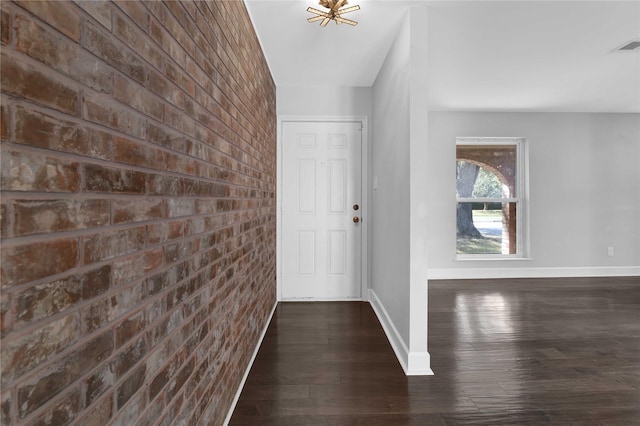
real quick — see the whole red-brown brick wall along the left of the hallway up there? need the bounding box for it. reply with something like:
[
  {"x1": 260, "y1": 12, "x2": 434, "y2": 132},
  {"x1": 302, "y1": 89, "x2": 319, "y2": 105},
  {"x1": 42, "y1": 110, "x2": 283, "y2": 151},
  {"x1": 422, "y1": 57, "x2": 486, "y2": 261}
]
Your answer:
[{"x1": 0, "y1": 1, "x2": 276, "y2": 425}]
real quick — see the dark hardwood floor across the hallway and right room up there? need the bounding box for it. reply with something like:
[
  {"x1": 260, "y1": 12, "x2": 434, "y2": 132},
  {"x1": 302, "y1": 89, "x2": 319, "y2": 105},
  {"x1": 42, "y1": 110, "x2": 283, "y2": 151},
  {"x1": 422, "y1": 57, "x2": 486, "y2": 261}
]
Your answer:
[{"x1": 230, "y1": 277, "x2": 640, "y2": 426}]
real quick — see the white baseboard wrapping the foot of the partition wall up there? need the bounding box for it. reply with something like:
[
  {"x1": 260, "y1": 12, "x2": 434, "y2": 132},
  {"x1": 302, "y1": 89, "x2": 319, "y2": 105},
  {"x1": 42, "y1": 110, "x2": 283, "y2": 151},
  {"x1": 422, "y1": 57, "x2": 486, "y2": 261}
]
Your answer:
[{"x1": 369, "y1": 289, "x2": 433, "y2": 376}]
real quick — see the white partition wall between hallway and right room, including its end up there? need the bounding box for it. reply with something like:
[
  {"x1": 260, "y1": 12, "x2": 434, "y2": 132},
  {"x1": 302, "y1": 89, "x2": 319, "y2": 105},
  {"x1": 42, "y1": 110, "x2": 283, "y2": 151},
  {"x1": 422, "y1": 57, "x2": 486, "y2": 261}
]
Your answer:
[{"x1": 370, "y1": 7, "x2": 431, "y2": 374}]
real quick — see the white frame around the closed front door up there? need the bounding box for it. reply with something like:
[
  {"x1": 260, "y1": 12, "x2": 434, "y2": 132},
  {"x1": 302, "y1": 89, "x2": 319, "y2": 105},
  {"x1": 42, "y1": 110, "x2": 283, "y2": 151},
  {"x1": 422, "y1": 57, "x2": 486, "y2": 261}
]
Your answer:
[{"x1": 276, "y1": 115, "x2": 372, "y2": 301}]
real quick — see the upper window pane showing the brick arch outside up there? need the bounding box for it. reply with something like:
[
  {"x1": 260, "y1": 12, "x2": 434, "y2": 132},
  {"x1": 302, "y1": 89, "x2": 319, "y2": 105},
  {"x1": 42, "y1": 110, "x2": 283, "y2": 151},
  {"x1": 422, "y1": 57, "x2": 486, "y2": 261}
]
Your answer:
[{"x1": 456, "y1": 144, "x2": 518, "y2": 198}]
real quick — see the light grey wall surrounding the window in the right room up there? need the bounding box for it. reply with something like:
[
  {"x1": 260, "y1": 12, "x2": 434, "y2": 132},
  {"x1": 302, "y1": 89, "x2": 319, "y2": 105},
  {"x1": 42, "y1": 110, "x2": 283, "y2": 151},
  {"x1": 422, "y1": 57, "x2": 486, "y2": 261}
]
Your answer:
[{"x1": 427, "y1": 112, "x2": 640, "y2": 278}]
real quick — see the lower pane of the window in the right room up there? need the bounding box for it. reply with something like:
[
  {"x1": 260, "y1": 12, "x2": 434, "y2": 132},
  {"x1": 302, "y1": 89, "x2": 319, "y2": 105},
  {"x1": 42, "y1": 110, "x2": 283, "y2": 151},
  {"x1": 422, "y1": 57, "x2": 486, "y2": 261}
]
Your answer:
[{"x1": 456, "y1": 203, "x2": 517, "y2": 255}]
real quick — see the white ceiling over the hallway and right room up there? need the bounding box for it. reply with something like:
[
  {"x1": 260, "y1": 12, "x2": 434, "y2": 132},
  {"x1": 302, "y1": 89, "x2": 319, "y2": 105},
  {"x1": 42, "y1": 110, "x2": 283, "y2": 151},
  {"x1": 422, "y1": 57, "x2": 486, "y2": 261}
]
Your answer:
[{"x1": 245, "y1": 0, "x2": 640, "y2": 112}]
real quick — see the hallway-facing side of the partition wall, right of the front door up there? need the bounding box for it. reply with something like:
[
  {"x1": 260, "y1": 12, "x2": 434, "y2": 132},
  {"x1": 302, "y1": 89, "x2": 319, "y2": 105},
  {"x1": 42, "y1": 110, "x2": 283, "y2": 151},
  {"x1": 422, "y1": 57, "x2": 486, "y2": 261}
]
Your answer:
[{"x1": 370, "y1": 10, "x2": 410, "y2": 357}]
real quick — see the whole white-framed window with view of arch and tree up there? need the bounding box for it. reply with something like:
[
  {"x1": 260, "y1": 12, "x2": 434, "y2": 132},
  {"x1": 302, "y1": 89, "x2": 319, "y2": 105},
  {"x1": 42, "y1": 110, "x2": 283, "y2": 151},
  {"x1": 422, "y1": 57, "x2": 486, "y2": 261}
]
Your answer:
[{"x1": 456, "y1": 138, "x2": 526, "y2": 259}]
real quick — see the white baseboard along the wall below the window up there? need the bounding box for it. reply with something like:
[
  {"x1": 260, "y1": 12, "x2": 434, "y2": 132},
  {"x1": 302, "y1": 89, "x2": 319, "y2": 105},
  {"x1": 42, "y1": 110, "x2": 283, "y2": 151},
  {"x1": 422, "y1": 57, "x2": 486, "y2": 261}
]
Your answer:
[{"x1": 428, "y1": 266, "x2": 640, "y2": 280}]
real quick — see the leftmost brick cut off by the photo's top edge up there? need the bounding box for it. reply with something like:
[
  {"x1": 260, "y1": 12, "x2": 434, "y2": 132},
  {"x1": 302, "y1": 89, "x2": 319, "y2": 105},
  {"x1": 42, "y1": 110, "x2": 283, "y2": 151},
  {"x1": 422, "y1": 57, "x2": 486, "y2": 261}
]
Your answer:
[{"x1": 18, "y1": 0, "x2": 80, "y2": 41}]
